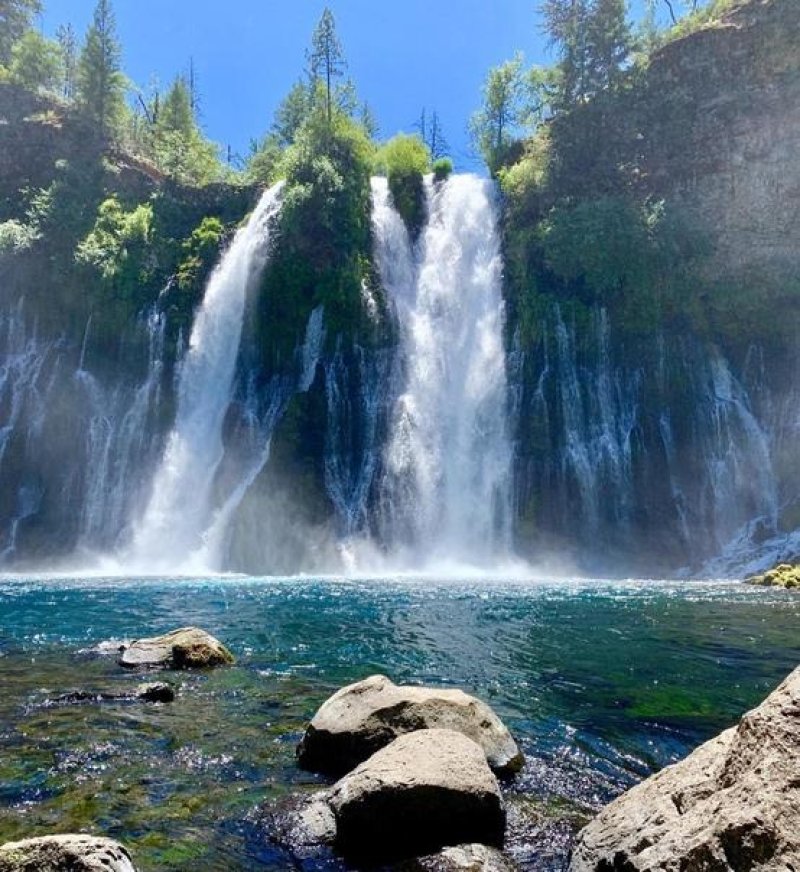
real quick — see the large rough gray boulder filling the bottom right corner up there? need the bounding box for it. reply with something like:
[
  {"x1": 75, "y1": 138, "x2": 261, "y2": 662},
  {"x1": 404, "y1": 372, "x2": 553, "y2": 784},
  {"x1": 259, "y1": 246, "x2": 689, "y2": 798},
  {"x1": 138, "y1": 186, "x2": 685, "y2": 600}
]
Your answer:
[{"x1": 570, "y1": 669, "x2": 800, "y2": 872}]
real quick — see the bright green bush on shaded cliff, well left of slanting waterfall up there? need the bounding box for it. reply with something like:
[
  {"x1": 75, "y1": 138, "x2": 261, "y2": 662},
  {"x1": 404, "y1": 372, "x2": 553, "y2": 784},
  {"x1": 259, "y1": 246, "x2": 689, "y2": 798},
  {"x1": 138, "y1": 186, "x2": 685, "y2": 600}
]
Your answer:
[{"x1": 75, "y1": 196, "x2": 153, "y2": 285}]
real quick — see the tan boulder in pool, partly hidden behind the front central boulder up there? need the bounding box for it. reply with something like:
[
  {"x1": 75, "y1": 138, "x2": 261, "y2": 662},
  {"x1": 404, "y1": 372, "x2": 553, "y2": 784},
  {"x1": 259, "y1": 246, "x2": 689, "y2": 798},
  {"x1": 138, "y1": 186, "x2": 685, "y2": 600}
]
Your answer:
[{"x1": 297, "y1": 675, "x2": 524, "y2": 775}]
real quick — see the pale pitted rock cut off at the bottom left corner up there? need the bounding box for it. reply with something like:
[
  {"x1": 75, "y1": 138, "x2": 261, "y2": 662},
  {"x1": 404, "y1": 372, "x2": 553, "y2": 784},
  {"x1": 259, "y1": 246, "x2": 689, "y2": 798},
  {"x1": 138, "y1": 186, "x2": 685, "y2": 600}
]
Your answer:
[{"x1": 0, "y1": 834, "x2": 136, "y2": 872}]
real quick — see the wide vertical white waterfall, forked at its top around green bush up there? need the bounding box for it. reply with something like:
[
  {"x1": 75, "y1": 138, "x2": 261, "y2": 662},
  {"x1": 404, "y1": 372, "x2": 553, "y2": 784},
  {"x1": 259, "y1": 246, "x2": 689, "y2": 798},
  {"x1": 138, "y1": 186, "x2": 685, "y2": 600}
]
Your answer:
[{"x1": 373, "y1": 175, "x2": 511, "y2": 568}]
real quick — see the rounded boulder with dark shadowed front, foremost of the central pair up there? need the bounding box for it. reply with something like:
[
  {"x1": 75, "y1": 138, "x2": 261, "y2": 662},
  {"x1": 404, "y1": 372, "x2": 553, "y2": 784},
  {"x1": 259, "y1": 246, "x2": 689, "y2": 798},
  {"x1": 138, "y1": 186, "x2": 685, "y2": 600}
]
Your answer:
[{"x1": 328, "y1": 729, "x2": 506, "y2": 861}]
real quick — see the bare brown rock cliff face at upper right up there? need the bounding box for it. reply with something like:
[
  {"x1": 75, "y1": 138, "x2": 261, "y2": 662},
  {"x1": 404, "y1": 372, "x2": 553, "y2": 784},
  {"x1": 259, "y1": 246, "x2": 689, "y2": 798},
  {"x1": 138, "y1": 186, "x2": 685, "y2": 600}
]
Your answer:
[{"x1": 644, "y1": 0, "x2": 800, "y2": 280}]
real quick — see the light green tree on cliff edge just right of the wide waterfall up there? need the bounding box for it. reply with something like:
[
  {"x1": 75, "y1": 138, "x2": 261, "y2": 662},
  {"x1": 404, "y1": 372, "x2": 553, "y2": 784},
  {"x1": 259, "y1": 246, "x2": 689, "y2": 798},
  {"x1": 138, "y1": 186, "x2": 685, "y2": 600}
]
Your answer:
[{"x1": 470, "y1": 53, "x2": 525, "y2": 175}]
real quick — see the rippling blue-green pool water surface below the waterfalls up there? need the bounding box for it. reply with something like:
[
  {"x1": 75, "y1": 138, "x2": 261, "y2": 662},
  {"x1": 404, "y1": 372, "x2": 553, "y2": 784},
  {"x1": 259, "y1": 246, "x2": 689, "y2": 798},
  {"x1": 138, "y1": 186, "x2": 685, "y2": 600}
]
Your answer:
[{"x1": 0, "y1": 577, "x2": 800, "y2": 870}]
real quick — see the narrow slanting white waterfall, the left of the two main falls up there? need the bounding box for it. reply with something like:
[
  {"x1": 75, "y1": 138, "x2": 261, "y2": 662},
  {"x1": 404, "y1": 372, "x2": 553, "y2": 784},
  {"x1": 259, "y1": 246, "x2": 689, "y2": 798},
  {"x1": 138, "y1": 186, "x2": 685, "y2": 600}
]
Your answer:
[{"x1": 126, "y1": 183, "x2": 282, "y2": 570}]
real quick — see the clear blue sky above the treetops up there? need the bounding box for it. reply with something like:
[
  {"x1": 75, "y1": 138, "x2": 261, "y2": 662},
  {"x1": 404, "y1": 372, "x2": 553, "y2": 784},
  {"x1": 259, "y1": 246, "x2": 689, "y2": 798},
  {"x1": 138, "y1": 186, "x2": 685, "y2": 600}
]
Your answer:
[{"x1": 41, "y1": 0, "x2": 656, "y2": 169}]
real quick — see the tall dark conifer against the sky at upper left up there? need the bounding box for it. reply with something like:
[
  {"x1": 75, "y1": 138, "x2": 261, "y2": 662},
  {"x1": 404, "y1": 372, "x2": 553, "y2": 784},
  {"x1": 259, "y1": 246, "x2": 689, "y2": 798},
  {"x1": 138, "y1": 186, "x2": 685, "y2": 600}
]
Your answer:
[{"x1": 78, "y1": 0, "x2": 125, "y2": 138}]
